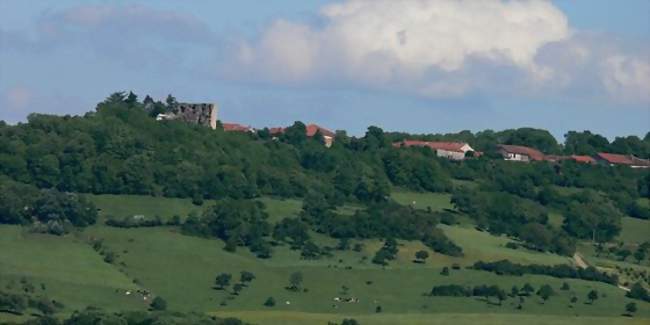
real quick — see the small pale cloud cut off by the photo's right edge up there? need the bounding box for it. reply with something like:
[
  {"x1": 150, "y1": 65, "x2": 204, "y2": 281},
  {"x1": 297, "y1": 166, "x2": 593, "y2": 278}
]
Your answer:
[{"x1": 601, "y1": 54, "x2": 650, "y2": 101}]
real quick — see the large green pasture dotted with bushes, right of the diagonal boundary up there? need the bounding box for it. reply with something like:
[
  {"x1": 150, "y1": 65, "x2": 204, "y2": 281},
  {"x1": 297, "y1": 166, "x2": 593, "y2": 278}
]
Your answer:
[{"x1": 82, "y1": 227, "x2": 650, "y2": 316}]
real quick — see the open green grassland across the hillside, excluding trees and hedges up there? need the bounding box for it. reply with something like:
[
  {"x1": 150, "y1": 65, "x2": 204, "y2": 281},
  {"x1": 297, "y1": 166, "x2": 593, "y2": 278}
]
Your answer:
[{"x1": 0, "y1": 193, "x2": 650, "y2": 325}]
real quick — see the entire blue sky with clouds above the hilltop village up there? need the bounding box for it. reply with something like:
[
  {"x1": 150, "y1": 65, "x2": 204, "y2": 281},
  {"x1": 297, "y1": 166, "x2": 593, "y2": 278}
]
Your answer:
[{"x1": 0, "y1": 0, "x2": 650, "y2": 139}]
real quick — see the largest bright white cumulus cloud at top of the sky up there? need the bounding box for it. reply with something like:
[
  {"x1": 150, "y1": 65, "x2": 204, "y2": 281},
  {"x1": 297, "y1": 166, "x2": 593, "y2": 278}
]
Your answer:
[{"x1": 230, "y1": 0, "x2": 571, "y2": 96}]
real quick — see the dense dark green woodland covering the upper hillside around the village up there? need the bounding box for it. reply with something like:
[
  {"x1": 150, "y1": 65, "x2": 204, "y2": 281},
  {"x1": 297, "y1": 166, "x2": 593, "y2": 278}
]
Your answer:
[{"x1": 0, "y1": 93, "x2": 650, "y2": 255}]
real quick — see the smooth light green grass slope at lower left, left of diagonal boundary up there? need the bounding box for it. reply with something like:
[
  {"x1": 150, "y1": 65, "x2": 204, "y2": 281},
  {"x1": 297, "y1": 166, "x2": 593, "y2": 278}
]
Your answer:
[{"x1": 0, "y1": 226, "x2": 136, "y2": 310}]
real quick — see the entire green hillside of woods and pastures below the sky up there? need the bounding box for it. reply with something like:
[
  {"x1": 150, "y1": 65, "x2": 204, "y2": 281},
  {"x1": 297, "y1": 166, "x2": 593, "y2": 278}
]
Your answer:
[{"x1": 0, "y1": 93, "x2": 650, "y2": 324}]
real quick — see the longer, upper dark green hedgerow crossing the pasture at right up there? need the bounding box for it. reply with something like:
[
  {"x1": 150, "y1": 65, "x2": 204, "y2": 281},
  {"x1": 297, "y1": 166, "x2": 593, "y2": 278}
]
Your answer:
[{"x1": 472, "y1": 260, "x2": 618, "y2": 284}]
